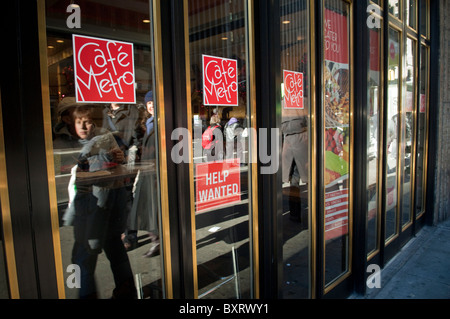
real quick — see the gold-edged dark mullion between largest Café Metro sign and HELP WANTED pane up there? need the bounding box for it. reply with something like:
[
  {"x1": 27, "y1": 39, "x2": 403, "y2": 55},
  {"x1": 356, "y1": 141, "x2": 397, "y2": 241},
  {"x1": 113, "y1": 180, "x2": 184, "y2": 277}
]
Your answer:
[{"x1": 154, "y1": 0, "x2": 194, "y2": 298}]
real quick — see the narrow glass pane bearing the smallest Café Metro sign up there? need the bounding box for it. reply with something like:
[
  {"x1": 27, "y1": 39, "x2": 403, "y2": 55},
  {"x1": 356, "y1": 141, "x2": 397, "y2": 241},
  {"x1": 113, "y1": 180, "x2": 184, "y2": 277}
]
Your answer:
[{"x1": 280, "y1": 0, "x2": 311, "y2": 298}]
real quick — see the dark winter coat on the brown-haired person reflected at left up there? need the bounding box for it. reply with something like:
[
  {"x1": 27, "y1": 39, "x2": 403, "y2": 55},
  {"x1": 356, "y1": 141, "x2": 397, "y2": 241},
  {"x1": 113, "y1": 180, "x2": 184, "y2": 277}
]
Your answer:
[{"x1": 71, "y1": 128, "x2": 126, "y2": 254}]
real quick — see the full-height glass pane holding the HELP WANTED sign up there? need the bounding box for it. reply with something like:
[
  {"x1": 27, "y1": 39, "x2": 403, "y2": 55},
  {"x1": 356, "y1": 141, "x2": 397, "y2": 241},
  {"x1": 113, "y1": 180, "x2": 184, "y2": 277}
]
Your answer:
[{"x1": 188, "y1": 0, "x2": 252, "y2": 298}]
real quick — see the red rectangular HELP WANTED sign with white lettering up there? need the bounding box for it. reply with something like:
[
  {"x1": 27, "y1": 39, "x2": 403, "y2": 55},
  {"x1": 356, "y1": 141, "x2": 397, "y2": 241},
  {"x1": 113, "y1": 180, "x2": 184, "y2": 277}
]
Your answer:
[{"x1": 195, "y1": 159, "x2": 241, "y2": 213}]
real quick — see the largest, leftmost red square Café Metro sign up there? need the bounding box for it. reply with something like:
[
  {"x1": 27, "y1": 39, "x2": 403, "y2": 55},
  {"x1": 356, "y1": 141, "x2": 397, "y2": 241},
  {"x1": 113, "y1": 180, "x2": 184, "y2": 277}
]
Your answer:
[{"x1": 72, "y1": 34, "x2": 136, "y2": 104}]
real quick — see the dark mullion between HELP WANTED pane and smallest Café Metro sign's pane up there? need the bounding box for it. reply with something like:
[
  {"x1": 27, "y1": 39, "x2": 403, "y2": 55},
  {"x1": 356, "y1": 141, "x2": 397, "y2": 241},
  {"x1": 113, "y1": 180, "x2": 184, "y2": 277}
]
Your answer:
[{"x1": 254, "y1": 1, "x2": 282, "y2": 298}]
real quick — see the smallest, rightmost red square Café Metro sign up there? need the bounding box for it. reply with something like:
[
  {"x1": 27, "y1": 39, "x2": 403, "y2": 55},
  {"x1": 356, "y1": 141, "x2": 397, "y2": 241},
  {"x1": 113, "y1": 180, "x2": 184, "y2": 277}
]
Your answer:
[{"x1": 283, "y1": 70, "x2": 303, "y2": 109}]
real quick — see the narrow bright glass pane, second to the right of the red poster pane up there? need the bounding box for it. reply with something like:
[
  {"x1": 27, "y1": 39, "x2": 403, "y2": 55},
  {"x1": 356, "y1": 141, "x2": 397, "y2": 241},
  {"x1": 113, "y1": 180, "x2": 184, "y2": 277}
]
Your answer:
[{"x1": 384, "y1": 28, "x2": 400, "y2": 239}]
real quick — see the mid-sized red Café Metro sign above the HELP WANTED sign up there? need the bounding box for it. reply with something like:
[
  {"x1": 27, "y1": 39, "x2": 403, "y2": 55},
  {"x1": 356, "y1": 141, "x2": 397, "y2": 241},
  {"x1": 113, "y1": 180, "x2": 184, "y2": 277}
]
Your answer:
[{"x1": 202, "y1": 55, "x2": 238, "y2": 106}]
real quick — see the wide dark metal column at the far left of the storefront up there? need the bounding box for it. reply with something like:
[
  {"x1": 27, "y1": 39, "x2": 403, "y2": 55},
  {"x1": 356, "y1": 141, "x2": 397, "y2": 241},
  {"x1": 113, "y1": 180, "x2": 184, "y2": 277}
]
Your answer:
[{"x1": 0, "y1": 1, "x2": 58, "y2": 298}]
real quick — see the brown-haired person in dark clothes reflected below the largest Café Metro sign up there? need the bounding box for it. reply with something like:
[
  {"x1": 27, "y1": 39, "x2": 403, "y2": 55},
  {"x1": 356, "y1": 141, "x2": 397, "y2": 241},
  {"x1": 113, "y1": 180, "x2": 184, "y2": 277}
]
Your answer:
[{"x1": 72, "y1": 105, "x2": 136, "y2": 299}]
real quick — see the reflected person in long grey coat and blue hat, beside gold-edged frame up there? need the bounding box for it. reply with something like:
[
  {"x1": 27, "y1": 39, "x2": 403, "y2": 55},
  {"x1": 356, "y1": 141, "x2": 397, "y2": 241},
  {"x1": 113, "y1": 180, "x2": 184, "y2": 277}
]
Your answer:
[{"x1": 127, "y1": 91, "x2": 159, "y2": 257}]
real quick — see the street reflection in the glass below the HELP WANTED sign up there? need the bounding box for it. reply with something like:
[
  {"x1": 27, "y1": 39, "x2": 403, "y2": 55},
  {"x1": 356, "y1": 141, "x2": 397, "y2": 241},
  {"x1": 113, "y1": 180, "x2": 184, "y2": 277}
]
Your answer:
[{"x1": 196, "y1": 204, "x2": 250, "y2": 298}]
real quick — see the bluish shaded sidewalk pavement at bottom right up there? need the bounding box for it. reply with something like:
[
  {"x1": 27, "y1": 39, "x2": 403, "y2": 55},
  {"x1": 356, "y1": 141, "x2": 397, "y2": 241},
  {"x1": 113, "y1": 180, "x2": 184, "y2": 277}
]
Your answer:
[{"x1": 350, "y1": 219, "x2": 450, "y2": 299}]
